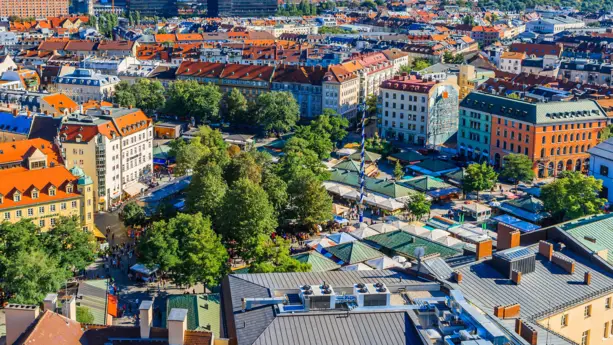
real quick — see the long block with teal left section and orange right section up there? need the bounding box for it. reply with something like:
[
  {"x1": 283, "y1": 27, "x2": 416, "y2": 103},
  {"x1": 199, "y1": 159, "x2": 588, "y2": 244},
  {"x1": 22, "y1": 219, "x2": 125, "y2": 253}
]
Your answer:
[{"x1": 458, "y1": 92, "x2": 607, "y2": 177}]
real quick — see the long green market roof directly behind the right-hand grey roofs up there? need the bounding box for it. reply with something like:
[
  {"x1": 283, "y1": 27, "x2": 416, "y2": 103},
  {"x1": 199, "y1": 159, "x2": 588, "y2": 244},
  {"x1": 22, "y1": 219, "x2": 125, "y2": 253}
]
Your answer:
[{"x1": 365, "y1": 230, "x2": 462, "y2": 259}]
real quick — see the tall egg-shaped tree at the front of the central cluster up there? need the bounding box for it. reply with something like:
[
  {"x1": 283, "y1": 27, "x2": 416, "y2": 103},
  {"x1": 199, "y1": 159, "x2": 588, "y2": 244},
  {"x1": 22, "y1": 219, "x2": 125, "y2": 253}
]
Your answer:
[{"x1": 215, "y1": 178, "x2": 277, "y2": 258}]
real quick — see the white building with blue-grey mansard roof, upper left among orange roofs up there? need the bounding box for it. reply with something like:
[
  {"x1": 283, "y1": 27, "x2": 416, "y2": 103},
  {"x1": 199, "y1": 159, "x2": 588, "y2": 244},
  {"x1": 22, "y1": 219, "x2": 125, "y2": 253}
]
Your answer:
[{"x1": 52, "y1": 68, "x2": 120, "y2": 103}]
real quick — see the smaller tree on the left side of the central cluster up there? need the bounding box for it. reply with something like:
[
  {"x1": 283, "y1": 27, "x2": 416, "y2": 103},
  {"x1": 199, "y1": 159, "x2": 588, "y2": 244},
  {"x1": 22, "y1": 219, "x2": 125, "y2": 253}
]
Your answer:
[{"x1": 186, "y1": 162, "x2": 228, "y2": 216}]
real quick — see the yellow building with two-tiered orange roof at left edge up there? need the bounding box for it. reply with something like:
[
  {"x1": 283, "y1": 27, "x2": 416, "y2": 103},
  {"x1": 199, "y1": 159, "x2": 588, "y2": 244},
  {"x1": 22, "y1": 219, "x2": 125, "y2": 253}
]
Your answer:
[{"x1": 0, "y1": 139, "x2": 94, "y2": 231}]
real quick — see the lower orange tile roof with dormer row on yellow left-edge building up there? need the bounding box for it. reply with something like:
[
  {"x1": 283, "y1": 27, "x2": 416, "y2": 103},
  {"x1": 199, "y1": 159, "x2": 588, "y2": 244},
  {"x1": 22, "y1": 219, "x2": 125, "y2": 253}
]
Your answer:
[{"x1": 0, "y1": 165, "x2": 79, "y2": 209}]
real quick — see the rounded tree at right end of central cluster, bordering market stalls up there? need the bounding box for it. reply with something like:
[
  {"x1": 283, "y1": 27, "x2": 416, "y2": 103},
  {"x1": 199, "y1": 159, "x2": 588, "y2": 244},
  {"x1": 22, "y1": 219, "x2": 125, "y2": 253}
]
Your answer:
[{"x1": 288, "y1": 170, "x2": 332, "y2": 227}]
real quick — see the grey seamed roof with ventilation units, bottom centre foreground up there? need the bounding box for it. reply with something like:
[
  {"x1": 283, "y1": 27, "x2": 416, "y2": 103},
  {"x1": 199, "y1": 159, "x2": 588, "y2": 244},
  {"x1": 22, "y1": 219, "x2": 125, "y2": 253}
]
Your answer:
[{"x1": 224, "y1": 270, "x2": 424, "y2": 345}]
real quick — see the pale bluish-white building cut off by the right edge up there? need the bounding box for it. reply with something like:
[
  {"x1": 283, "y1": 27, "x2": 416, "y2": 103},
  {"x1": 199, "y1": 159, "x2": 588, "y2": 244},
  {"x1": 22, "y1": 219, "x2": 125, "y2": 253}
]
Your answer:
[{"x1": 587, "y1": 138, "x2": 613, "y2": 202}]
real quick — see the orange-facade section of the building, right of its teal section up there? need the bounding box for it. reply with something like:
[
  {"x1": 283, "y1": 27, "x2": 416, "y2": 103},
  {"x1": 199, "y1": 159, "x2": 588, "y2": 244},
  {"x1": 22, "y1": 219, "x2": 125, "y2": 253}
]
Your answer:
[{"x1": 490, "y1": 100, "x2": 607, "y2": 178}]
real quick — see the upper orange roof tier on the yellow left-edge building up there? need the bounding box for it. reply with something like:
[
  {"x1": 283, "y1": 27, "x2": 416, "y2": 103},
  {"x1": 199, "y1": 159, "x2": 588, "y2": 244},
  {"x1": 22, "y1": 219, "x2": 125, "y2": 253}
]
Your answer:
[{"x1": 0, "y1": 138, "x2": 61, "y2": 166}]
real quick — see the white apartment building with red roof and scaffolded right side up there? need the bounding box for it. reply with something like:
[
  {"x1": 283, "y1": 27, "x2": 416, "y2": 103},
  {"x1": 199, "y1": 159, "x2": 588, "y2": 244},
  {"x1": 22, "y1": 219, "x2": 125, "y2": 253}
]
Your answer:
[{"x1": 379, "y1": 73, "x2": 459, "y2": 146}]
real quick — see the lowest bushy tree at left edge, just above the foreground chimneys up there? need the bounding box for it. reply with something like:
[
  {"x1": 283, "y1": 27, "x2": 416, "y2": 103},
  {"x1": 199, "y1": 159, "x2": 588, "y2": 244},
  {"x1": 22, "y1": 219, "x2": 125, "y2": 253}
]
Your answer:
[{"x1": 0, "y1": 247, "x2": 69, "y2": 304}]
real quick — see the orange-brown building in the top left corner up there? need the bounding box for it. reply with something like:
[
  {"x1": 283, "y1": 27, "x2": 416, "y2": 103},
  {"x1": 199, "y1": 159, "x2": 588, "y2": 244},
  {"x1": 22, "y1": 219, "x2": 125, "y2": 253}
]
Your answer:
[{"x1": 0, "y1": 0, "x2": 69, "y2": 18}]
